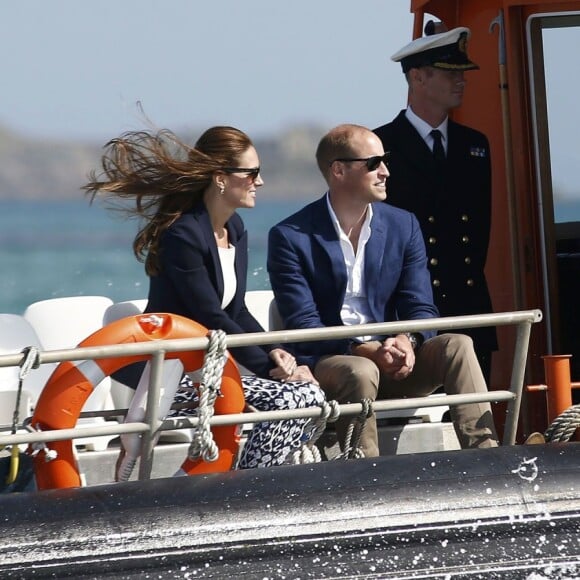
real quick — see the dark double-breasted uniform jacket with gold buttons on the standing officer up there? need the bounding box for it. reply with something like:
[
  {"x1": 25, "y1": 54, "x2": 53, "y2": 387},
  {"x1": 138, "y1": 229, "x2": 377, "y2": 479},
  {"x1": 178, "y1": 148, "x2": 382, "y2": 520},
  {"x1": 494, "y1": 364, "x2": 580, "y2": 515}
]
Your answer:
[{"x1": 375, "y1": 111, "x2": 497, "y2": 352}]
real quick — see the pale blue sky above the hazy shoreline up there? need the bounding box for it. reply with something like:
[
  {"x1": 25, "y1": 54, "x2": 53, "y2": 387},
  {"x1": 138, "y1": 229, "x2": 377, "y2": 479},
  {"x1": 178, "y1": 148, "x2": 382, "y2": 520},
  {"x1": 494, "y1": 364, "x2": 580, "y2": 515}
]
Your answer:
[{"x1": 0, "y1": 0, "x2": 412, "y2": 139}]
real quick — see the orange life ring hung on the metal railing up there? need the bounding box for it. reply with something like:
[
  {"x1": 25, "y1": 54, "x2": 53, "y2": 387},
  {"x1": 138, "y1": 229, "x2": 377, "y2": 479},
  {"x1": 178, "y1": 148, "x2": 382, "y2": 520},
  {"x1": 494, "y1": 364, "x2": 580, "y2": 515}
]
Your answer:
[{"x1": 31, "y1": 313, "x2": 245, "y2": 489}]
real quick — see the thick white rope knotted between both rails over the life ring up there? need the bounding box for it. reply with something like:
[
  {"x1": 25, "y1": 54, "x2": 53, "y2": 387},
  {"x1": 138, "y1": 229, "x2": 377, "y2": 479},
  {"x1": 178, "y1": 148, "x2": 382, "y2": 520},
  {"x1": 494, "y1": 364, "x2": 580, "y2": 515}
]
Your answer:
[{"x1": 187, "y1": 330, "x2": 226, "y2": 462}]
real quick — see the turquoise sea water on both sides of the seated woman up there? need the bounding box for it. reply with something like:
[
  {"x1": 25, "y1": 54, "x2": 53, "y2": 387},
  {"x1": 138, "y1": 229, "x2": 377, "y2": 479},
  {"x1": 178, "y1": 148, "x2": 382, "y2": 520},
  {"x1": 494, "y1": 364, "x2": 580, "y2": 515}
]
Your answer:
[{"x1": 0, "y1": 199, "x2": 306, "y2": 314}]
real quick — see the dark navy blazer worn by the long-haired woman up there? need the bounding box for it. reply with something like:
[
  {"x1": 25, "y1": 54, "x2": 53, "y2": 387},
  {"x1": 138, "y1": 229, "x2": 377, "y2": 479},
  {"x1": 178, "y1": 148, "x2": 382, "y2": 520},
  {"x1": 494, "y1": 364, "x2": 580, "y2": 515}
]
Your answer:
[{"x1": 145, "y1": 203, "x2": 278, "y2": 378}]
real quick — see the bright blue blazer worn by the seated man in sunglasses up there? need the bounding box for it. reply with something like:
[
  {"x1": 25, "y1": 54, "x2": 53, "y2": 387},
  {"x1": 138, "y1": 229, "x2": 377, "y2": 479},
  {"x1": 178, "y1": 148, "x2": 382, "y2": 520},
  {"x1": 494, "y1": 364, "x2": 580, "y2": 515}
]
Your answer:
[{"x1": 268, "y1": 196, "x2": 438, "y2": 366}]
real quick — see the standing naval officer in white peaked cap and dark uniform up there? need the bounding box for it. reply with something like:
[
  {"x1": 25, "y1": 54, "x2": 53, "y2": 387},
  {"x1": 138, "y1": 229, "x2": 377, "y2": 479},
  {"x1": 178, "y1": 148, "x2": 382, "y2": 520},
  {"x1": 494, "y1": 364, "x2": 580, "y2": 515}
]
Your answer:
[{"x1": 375, "y1": 23, "x2": 497, "y2": 382}]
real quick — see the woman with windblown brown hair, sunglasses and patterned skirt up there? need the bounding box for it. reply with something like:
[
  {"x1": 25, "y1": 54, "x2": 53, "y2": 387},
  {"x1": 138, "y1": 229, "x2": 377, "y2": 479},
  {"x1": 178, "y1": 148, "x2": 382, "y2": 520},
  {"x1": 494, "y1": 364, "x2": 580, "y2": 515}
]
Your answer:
[{"x1": 83, "y1": 126, "x2": 324, "y2": 468}]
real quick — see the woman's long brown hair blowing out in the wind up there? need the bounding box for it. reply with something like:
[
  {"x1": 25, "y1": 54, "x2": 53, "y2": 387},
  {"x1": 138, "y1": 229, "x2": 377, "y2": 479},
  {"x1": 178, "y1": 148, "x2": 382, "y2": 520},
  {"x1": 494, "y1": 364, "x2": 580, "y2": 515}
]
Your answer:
[{"x1": 82, "y1": 126, "x2": 252, "y2": 276}]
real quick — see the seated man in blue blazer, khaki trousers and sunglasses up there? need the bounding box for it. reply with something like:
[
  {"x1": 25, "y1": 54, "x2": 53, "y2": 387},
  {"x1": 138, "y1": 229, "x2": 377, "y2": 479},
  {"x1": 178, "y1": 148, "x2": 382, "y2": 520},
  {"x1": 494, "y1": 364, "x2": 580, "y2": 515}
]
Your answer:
[{"x1": 268, "y1": 125, "x2": 497, "y2": 457}]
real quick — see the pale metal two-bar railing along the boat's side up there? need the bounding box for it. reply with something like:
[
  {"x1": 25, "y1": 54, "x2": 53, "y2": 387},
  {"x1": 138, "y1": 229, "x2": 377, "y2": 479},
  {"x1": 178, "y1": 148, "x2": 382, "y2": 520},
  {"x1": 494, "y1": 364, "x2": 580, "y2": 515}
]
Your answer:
[{"x1": 0, "y1": 310, "x2": 542, "y2": 477}]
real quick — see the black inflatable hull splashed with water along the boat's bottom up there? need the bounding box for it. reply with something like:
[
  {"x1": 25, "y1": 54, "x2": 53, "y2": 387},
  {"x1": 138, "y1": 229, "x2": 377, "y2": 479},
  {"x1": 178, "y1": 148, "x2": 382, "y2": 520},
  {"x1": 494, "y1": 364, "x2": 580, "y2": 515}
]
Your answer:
[{"x1": 0, "y1": 443, "x2": 580, "y2": 579}]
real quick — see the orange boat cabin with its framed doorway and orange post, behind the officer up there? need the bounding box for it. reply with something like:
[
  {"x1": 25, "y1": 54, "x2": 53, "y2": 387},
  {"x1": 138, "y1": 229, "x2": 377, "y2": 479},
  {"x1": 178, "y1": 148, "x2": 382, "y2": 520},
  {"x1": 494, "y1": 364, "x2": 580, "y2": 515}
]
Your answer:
[{"x1": 411, "y1": 0, "x2": 580, "y2": 433}]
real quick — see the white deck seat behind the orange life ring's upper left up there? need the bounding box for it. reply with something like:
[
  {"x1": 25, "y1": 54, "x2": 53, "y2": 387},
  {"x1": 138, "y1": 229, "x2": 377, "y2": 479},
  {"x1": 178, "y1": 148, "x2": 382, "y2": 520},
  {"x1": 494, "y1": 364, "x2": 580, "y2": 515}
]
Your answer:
[{"x1": 24, "y1": 296, "x2": 116, "y2": 451}]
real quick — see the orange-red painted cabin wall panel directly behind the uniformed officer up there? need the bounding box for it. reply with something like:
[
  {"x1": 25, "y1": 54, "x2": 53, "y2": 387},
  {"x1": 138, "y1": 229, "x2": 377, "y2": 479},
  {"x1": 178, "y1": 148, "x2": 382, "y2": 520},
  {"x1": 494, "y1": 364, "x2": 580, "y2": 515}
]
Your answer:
[{"x1": 404, "y1": 0, "x2": 580, "y2": 432}]
